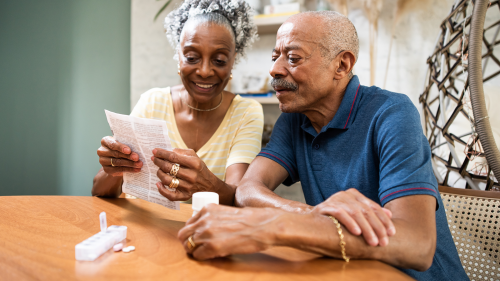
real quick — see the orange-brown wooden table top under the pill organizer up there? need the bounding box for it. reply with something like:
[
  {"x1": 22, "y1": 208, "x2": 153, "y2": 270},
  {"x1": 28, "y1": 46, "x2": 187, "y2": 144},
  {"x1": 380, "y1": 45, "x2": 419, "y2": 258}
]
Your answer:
[{"x1": 0, "y1": 196, "x2": 411, "y2": 281}]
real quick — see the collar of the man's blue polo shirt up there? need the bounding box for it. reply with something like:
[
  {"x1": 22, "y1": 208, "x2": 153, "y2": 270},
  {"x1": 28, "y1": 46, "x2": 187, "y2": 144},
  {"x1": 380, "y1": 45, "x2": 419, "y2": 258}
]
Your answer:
[{"x1": 302, "y1": 75, "x2": 361, "y2": 136}]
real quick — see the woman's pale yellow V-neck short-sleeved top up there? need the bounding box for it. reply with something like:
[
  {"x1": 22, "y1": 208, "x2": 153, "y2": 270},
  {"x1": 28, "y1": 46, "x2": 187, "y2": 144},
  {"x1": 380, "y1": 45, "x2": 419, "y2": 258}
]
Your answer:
[{"x1": 130, "y1": 87, "x2": 264, "y2": 180}]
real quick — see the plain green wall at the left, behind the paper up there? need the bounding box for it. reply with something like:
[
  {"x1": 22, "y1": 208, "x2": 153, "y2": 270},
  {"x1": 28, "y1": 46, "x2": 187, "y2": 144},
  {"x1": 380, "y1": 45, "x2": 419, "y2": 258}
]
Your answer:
[{"x1": 0, "y1": 0, "x2": 130, "y2": 195}]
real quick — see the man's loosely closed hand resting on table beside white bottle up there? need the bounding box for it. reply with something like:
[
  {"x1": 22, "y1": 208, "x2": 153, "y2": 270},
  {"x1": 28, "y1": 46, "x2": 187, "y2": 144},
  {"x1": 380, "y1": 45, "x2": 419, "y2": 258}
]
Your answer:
[{"x1": 177, "y1": 204, "x2": 285, "y2": 260}]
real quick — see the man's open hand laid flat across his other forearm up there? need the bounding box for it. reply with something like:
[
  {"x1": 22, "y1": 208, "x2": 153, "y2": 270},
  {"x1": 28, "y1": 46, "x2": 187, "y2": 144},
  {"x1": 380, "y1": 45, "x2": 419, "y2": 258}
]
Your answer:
[{"x1": 312, "y1": 188, "x2": 396, "y2": 246}]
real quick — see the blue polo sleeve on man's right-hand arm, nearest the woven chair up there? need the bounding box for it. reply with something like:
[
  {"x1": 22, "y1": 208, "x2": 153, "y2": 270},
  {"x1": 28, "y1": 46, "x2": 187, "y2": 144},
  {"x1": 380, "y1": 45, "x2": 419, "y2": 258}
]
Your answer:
[{"x1": 375, "y1": 95, "x2": 439, "y2": 207}]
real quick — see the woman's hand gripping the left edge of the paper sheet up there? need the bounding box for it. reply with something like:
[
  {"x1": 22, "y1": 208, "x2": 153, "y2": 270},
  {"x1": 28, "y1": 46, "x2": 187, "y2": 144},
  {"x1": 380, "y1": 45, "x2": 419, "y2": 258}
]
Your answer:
[{"x1": 97, "y1": 136, "x2": 143, "y2": 177}]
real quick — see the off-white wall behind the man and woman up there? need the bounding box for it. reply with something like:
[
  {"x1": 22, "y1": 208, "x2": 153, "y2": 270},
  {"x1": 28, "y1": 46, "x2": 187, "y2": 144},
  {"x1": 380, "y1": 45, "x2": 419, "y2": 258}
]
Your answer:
[{"x1": 130, "y1": 0, "x2": 454, "y2": 201}]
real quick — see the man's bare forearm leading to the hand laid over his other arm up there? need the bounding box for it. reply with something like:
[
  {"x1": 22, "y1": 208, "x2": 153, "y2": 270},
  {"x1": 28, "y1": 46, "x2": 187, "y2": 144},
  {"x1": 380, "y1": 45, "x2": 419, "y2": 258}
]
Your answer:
[{"x1": 235, "y1": 180, "x2": 313, "y2": 213}]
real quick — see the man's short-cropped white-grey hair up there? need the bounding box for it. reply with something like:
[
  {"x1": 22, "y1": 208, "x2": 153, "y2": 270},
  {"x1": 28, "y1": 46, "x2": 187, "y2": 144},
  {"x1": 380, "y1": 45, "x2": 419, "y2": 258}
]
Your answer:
[{"x1": 299, "y1": 11, "x2": 359, "y2": 60}]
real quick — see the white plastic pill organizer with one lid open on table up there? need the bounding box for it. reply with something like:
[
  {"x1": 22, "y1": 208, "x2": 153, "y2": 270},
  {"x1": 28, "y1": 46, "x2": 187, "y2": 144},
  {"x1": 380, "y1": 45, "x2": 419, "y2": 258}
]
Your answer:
[{"x1": 75, "y1": 213, "x2": 127, "y2": 261}]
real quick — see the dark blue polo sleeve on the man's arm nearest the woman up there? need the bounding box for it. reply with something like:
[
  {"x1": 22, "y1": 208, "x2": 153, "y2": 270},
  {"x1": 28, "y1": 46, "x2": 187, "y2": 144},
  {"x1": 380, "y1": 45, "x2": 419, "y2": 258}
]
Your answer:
[{"x1": 258, "y1": 113, "x2": 300, "y2": 186}]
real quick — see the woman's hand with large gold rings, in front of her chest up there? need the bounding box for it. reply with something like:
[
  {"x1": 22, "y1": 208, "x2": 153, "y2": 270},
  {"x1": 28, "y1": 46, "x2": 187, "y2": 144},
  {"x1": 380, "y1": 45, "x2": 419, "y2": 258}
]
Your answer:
[{"x1": 151, "y1": 148, "x2": 223, "y2": 201}]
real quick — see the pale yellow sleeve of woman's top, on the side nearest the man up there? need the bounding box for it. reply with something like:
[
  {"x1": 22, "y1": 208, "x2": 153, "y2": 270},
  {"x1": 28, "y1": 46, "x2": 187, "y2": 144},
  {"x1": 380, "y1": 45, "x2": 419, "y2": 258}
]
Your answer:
[{"x1": 226, "y1": 100, "x2": 264, "y2": 168}]
